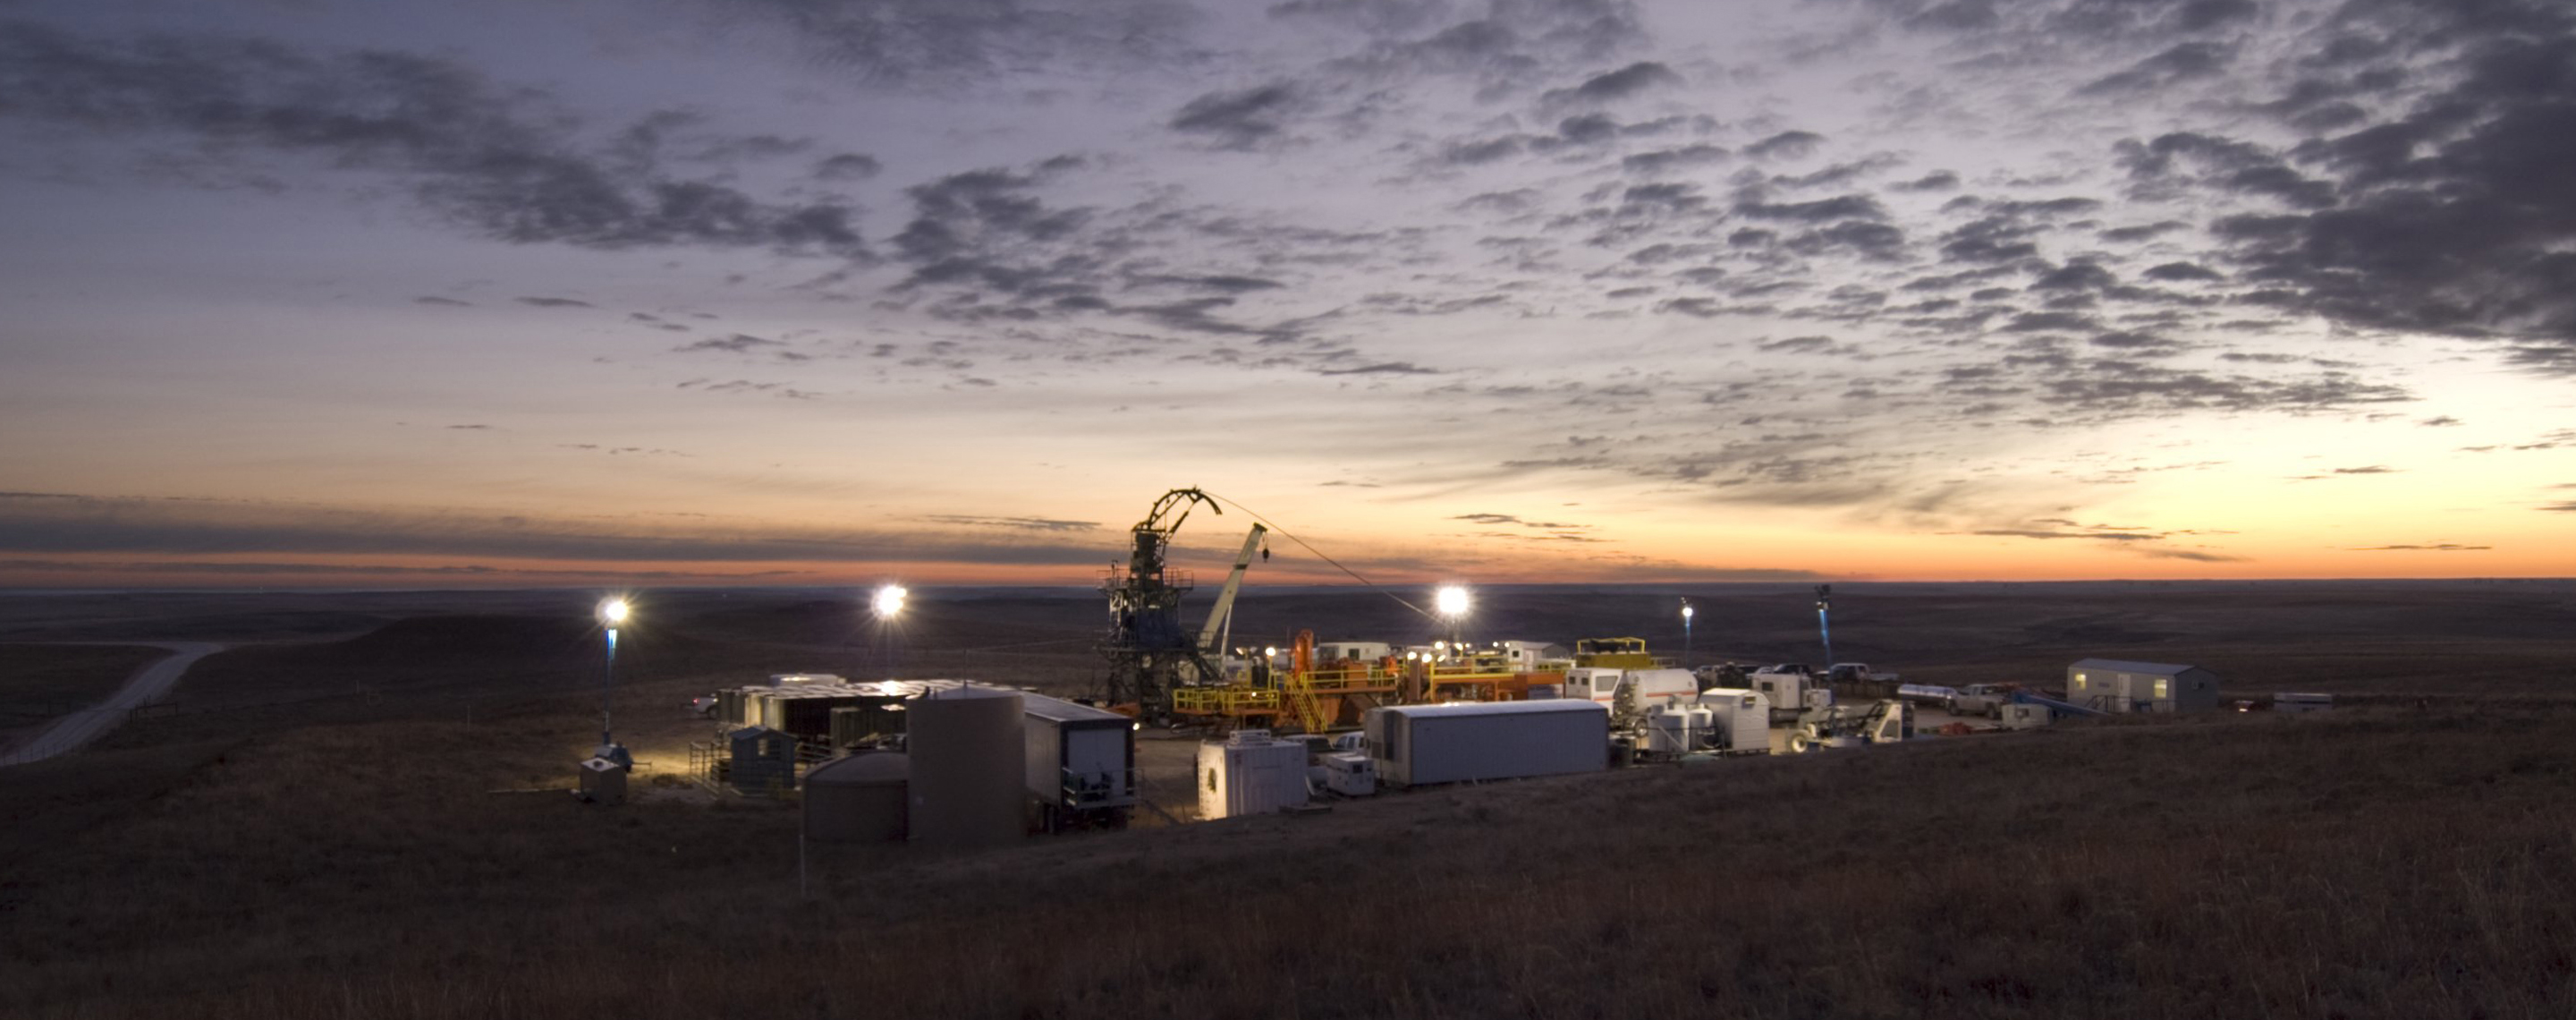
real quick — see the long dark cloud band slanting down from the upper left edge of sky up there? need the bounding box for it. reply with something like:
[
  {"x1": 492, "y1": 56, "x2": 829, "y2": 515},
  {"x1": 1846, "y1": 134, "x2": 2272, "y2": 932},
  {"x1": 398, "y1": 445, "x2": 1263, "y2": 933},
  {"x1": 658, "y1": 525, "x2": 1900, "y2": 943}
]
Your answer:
[{"x1": 0, "y1": 23, "x2": 866, "y2": 258}]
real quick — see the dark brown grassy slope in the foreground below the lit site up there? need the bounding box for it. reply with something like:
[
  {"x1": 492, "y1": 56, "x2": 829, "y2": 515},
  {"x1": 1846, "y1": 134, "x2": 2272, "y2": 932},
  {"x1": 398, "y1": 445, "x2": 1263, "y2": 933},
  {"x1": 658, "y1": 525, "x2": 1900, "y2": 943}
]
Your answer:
[{"x1": 0, "y1": 680, "x2": 2576, "y2": 1017}]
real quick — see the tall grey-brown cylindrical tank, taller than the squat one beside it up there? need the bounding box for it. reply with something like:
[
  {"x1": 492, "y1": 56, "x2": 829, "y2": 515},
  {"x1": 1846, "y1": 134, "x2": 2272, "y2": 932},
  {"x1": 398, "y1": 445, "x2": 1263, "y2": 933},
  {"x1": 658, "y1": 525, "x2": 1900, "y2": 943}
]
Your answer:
[{"x1": 904, "y1": 688, "x2": 1028, "y2": 847}]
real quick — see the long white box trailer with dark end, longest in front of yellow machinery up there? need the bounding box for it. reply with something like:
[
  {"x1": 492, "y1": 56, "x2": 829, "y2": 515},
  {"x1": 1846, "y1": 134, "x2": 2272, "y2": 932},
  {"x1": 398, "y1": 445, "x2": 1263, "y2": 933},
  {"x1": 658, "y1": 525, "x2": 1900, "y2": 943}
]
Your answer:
[{"x1": 1360, "y1": 698, "x2": 1610, "y2": 786}]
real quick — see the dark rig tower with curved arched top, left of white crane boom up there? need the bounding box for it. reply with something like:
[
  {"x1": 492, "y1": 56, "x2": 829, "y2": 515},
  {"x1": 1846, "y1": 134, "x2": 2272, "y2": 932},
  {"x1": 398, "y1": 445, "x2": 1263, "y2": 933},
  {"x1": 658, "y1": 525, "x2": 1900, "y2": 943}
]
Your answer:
[{"x1": 1100, "y1": 489, "x2": 1250, "y2": 721}]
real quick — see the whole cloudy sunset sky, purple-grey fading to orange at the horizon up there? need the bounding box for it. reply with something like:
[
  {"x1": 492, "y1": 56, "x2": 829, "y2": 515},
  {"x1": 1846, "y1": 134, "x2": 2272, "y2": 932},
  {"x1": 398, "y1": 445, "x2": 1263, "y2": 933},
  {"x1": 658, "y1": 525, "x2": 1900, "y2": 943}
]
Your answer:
[{"x1": 0, "y1": 0, "x2": 2576, "y2": 587}]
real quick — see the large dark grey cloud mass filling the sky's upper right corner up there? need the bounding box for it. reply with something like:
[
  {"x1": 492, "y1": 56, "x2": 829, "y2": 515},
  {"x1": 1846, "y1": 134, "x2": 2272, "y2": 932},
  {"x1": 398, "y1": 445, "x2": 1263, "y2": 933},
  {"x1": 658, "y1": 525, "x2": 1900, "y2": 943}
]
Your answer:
[{"x1": 2192, "y1": 0, "x2": 2576, "y2": 376}]
